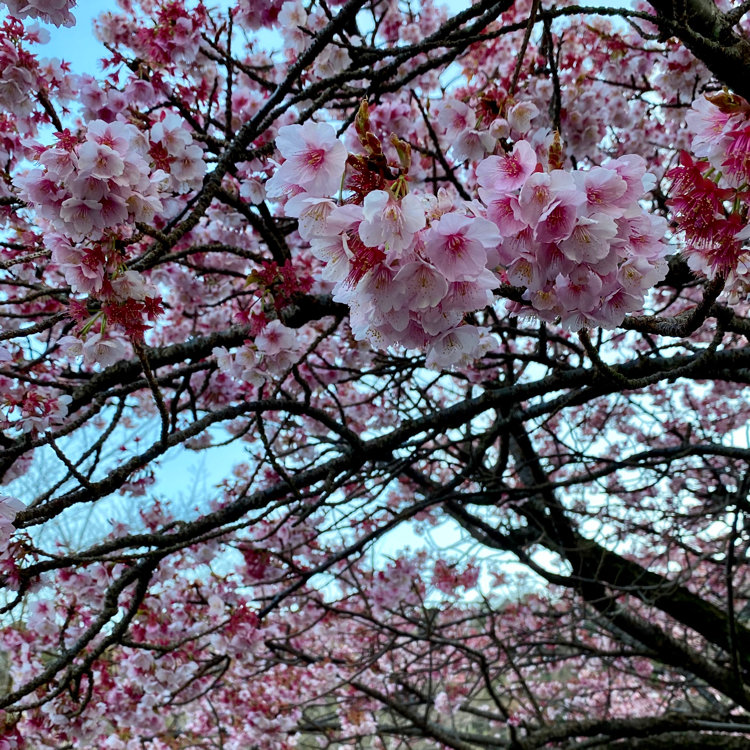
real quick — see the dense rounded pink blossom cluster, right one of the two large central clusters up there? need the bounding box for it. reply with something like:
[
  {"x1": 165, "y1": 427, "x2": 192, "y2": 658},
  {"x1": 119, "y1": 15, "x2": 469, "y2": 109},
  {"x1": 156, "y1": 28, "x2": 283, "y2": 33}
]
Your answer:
[{"x1": 496, "y1": 147, "x2": 667, "y2": 330}]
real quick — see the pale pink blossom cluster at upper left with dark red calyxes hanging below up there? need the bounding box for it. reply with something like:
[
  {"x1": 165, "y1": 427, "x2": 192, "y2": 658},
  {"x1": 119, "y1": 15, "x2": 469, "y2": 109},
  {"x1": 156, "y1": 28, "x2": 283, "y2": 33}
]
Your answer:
[{"x1": 15, "y1": 112, "x2": 206, "y2": 356}]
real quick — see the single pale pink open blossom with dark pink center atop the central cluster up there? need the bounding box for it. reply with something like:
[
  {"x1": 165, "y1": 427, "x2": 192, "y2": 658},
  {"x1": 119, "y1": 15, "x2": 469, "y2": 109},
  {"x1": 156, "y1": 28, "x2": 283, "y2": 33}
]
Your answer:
[{"x1": 266, "y1": 121, "x2": 347, "y2": 197}]
